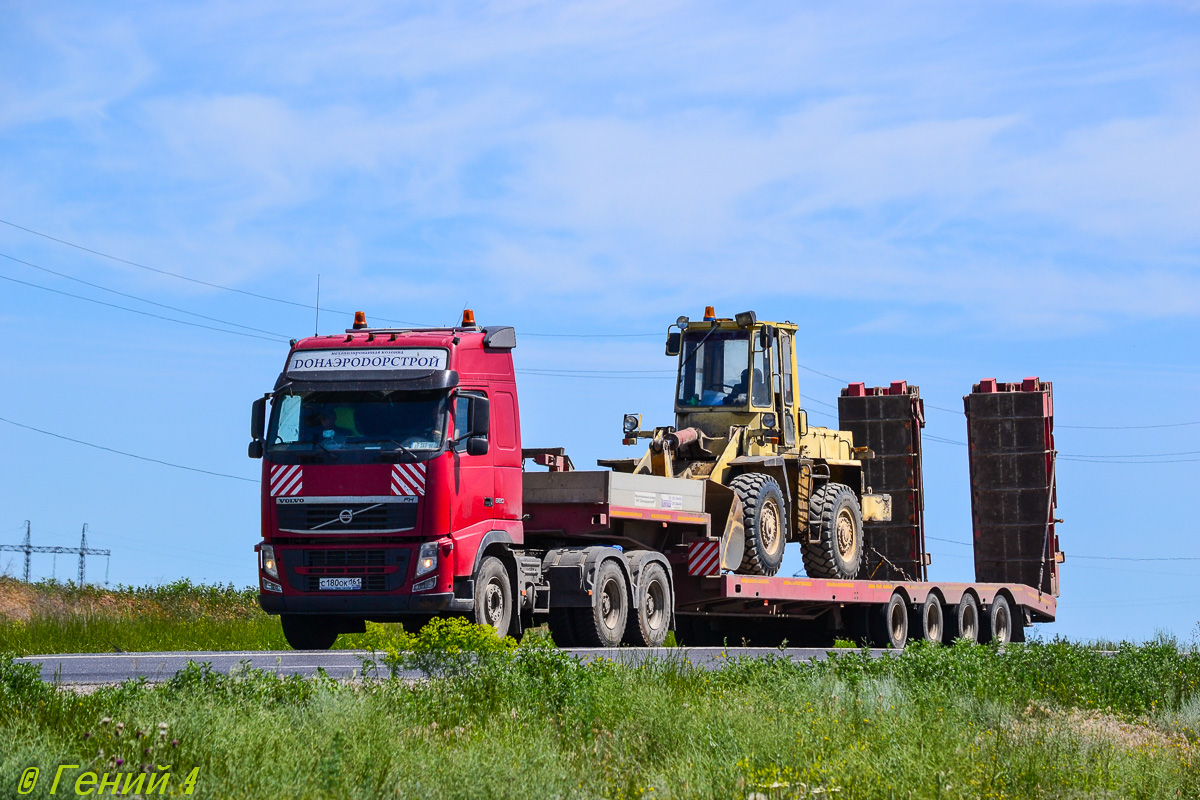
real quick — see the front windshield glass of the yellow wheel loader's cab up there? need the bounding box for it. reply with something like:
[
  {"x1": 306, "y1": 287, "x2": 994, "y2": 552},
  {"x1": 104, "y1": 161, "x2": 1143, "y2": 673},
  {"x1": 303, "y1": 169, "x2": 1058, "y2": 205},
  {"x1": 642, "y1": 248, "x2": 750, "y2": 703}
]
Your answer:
[{"x1": 677, "y1": 330, "x2": 748, "y2": 405}]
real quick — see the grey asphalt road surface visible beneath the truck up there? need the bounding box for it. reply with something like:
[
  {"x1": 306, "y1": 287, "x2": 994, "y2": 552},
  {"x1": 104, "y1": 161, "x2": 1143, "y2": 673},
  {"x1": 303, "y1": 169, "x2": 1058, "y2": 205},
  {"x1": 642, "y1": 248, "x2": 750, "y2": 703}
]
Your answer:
[{"x1": 16, "y1": 648, "x2": 882, "y2": 686}]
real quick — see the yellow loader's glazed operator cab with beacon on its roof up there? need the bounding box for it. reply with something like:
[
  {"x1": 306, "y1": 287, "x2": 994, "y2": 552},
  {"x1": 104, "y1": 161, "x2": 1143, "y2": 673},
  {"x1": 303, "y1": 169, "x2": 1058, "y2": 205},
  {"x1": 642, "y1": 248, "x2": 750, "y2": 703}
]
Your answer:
[{"x1": 667, "y1": 308, "x2": 802, "y2": 447}]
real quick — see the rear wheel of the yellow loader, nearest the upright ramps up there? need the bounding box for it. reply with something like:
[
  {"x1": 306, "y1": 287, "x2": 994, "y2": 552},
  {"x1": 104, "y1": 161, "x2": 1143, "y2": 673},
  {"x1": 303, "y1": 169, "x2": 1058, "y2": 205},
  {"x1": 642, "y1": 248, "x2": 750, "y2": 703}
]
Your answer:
[{"x1": 802, "y1": 483, "x2": 864, "y2": 581}]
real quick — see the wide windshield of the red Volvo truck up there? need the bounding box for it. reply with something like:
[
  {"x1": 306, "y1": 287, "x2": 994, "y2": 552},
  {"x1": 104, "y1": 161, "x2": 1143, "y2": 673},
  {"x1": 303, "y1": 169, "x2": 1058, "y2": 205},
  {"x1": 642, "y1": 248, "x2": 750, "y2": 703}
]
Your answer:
[{"x1": 266, "y1": 391, "x2": 448, "y2": 461}]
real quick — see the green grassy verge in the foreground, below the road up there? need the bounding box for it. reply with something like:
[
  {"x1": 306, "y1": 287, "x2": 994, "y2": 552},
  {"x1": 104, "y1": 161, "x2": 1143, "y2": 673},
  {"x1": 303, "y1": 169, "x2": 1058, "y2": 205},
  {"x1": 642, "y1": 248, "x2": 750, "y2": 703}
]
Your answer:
[{"x1": 0, "y1": 620, "x2": 1200, "y2": 800}]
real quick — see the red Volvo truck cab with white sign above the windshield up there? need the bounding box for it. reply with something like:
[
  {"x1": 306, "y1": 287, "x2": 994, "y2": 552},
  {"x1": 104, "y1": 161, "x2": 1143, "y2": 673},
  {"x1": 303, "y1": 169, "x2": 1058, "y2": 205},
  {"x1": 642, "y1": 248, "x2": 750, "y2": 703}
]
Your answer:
[{"x1": 250, "y1": 312, "x2": 523, "y2": 648}]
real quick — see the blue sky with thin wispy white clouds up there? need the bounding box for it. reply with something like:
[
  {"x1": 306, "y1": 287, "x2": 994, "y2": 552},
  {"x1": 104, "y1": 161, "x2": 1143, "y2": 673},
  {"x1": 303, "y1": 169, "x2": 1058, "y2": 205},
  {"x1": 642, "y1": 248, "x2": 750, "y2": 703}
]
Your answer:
[{"x1": 0, "y1": 1, "x2": 1200, "y2": 638}]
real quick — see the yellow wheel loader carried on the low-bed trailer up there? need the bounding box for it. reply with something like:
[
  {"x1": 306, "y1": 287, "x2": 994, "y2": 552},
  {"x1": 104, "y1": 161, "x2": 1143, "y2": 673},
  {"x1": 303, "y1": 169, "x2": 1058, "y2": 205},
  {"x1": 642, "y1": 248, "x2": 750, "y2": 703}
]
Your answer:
[{"x1": 600, "y1": 306, "x2": 892, "y2": 579}]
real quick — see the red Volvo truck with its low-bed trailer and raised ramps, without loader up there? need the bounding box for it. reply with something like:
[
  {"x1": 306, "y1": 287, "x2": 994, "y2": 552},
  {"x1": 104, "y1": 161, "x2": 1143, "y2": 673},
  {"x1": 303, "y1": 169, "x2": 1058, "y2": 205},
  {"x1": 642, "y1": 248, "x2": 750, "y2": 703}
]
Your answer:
[{"x1": 250, "y1": 312, "x2": 1062, "y2": 649}]
